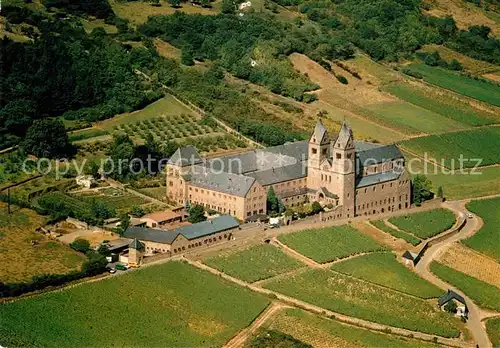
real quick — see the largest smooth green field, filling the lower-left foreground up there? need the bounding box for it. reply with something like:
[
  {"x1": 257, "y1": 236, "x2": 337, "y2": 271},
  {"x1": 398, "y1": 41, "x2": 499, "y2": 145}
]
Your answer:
[{"x1": 0, "y1": 262, "x2": 269, "y2": 347}]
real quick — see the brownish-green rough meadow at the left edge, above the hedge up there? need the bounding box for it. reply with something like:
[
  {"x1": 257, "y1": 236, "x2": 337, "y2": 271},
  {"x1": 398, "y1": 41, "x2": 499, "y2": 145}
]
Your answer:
[{"x1": 0, "y1": 203, "x2": 86, "y2": 283}]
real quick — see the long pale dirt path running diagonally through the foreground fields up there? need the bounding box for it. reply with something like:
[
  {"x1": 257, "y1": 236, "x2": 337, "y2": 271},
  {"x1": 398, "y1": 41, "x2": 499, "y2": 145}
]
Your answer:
[{"x1": 184, "y1": 258, "x2": 469, "y2": 347}]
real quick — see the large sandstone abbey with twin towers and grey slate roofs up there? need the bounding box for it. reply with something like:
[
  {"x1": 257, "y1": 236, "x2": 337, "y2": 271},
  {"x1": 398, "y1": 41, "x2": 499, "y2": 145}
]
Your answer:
[{"x1": 167, "y1": 121, "x2": 411, "y2": 220}]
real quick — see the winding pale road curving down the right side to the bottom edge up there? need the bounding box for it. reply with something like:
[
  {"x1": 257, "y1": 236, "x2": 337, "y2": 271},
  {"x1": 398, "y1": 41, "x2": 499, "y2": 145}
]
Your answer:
[{"x1": 415, "y1": 202, "x2": 492, "y2": 347}]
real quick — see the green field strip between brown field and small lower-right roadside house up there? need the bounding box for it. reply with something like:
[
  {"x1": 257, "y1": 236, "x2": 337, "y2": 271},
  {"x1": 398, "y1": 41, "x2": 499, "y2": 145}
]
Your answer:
[{"x1": 430, "y1": 261, "x2": 500, "y2": 312}]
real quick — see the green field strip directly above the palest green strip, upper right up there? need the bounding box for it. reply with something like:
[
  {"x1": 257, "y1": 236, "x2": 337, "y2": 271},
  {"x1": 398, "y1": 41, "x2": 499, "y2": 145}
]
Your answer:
[{"x1": 383, "y1": 83, "x2": 500, "y2": 126}]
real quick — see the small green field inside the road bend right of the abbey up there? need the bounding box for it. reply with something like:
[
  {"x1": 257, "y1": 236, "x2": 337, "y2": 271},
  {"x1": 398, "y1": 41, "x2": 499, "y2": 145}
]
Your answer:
[{"x1": 389, "y1": 209, "x2": 455, "y2": 239}]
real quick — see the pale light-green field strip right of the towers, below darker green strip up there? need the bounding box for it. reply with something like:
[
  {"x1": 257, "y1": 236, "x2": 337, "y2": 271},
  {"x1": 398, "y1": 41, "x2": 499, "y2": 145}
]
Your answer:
[{"x1": 368, "y1": 101, "x2": 467, "y2": 133}]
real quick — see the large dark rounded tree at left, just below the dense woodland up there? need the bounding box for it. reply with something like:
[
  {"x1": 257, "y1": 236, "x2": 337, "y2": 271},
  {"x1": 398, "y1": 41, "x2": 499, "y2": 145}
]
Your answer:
[{"x1": 22, "y1": 119, "x2": 74, "y2": 158}]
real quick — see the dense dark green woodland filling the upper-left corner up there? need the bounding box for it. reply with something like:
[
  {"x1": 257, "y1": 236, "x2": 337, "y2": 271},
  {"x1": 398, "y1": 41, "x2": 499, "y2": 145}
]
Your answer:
[{"x1": 0, "y1": 5, "x2": 162, "y2": 157}]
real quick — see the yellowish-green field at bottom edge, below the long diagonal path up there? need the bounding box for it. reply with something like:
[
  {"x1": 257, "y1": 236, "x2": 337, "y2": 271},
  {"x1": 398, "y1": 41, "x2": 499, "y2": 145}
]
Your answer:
[{"x1": 268, "y1": 309, "x2": 436, "y2": 348}]
